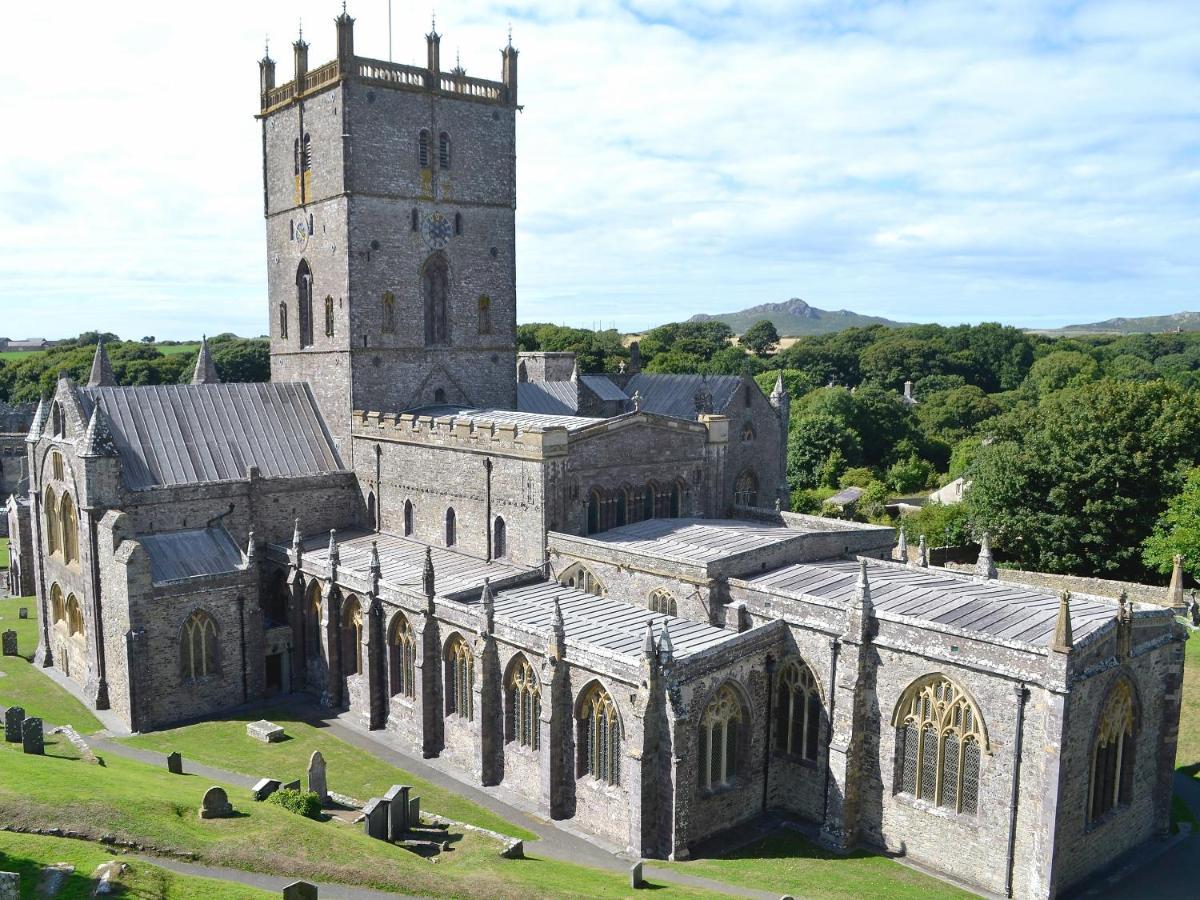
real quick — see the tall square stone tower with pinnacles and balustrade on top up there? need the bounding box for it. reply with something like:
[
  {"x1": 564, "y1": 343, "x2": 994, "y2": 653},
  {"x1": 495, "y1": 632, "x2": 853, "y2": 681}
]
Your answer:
[{"x1": 257, "y1": 12, "x2": 517, "y2": 463}]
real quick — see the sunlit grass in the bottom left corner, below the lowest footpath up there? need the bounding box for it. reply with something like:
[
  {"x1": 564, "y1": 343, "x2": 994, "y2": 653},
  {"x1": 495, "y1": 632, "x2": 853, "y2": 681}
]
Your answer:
[{"x1": 0, "y1": 833, "x2": 277, "y2": 900}]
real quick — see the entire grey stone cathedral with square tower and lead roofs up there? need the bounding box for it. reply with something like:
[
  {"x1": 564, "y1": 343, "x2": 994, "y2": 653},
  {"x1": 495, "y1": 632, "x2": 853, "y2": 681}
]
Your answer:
[{"x1": 10, "y1": 12, "x2": 1184, "y2": 898}]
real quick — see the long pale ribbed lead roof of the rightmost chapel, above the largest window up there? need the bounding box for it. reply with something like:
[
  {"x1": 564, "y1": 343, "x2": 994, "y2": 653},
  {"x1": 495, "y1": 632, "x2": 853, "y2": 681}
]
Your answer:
[{"x1": 746, "y1": 559, "x2": 1116, "y2": 647}]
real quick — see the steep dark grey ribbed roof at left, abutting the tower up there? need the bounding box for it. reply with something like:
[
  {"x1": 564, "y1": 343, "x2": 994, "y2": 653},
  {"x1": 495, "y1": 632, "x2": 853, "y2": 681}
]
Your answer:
[{"x1": 79, "y1": 383, "x2": 343, "y2": 491}]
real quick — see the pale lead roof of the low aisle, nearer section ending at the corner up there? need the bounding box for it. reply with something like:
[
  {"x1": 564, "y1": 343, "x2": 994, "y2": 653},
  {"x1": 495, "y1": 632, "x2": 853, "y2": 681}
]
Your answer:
[{"x1": 494, "y1": 581, "x2": 734, "y2": 660}]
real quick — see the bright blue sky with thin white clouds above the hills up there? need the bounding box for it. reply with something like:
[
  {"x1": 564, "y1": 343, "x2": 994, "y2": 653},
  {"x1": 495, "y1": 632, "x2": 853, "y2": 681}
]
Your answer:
[{"x1": 0, "y1": 0, "x2": 1200, "y2": 338}]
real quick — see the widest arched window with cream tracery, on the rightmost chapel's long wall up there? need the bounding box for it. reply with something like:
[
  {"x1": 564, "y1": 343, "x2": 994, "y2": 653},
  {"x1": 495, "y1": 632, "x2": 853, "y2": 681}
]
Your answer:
[{"x1": 893, "y1": 674, "x2": 988, "y2": 815}]
